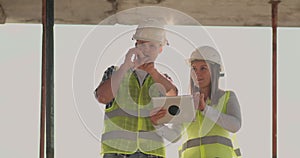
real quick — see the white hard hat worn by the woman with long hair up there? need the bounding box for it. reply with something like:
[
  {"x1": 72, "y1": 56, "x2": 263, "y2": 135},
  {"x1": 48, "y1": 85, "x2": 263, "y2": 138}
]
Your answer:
[{"x1": 188, "y1": 46, "x2": 223, "y2": 71}]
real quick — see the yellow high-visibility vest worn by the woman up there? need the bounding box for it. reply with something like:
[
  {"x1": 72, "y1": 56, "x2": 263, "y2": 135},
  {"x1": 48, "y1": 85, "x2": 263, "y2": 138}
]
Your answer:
[{"x1": 179, "y1": 91, "x2": 241, "y2": 158}]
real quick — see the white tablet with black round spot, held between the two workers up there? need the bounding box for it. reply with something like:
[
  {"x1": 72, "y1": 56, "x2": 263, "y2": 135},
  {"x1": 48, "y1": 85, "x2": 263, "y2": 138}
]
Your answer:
[{"x1": 151, "y1": 95, "x2": 196, "y2": 124}]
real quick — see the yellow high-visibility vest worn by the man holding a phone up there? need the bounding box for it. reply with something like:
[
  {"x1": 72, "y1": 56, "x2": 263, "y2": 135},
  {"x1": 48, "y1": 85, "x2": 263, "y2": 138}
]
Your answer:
[{"x1": 101, "y1": 71, "x2": 165, "y2": 157}]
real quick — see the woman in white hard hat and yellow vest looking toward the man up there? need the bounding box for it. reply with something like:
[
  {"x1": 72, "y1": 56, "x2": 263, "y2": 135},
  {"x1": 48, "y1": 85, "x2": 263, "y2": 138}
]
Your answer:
[{"x1": 179, "y1": 46, "x2": 241, "y2": 158}]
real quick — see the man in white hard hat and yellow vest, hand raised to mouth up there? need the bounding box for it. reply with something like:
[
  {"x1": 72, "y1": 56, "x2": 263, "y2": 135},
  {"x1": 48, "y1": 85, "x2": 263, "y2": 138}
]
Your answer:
[{"x1": 95, "y1": 19, "x2": 180, "y2": 158}]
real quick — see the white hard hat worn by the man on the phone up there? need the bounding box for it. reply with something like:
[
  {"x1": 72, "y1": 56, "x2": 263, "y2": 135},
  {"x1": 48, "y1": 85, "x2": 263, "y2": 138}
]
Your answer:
[{"x1": 132, "y1": 19, "x2": 168, "y2": 45}]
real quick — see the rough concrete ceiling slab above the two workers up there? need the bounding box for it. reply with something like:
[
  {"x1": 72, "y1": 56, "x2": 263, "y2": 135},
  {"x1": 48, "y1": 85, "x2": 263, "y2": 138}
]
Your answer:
[{"x1": 0, "y1": 0, "x2": 300, "y2": 27}]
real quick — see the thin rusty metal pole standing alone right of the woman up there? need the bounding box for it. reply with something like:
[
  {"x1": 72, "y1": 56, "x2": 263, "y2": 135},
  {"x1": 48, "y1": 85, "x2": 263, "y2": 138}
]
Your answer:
[{"x1": 270, "y1": 0, "x2": 280, "y2": 158}]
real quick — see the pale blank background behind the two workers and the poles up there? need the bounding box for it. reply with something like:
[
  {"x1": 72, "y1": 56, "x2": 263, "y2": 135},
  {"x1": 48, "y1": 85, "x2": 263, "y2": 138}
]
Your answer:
[{"x1": 0, "y1": 24, "x2": 300, "y2": 158}]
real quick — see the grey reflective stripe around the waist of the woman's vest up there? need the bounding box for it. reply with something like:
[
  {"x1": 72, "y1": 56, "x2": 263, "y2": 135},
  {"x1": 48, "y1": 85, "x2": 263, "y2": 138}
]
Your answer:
[{"x1": 181, "y1": 136, "x2": 232, "y2": 152}]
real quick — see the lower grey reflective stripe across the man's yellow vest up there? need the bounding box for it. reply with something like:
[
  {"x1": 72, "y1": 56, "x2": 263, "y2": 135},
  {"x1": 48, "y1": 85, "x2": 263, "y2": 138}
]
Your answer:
[{"x1": 101, "y1": 131, "x2": 163, "y2": 142}]
